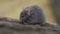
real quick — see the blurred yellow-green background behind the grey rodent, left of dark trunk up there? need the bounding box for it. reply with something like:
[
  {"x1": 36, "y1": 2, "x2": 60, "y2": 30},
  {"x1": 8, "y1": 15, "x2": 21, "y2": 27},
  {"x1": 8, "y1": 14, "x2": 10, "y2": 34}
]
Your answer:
[{"x1": 0, "y1": 0, "x2": 55, "y2": 22}]
